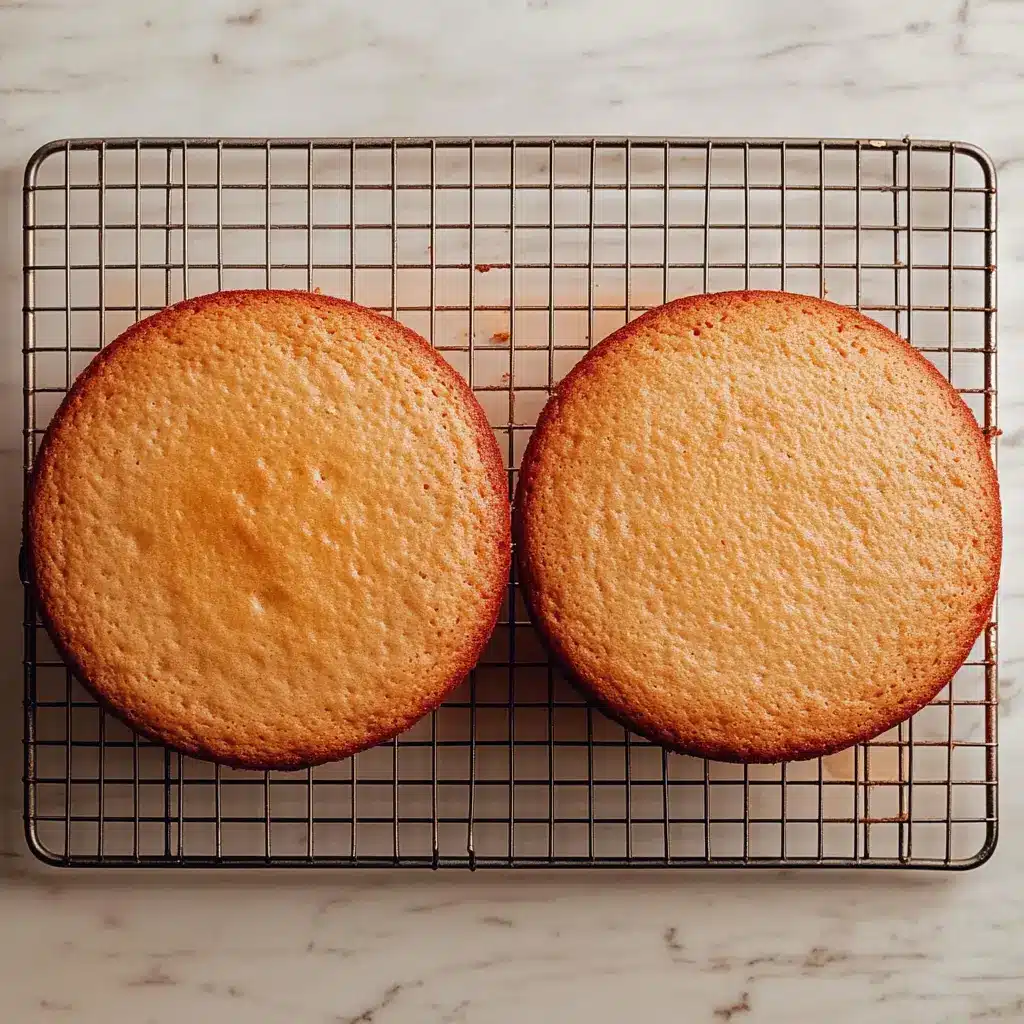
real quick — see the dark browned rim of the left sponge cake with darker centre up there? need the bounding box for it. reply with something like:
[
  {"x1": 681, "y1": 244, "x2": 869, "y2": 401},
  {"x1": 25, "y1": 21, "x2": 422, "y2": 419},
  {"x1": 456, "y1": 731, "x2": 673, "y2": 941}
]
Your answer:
[{"x1": 24, "y1": 289, "x2": 511, "y2": 771}]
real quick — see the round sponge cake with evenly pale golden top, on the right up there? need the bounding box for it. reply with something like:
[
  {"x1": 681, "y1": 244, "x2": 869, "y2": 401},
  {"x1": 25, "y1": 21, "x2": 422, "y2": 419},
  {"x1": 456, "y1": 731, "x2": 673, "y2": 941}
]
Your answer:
[{"x1": 515, "y1": 292, "x2": 1001, "y2": 762}]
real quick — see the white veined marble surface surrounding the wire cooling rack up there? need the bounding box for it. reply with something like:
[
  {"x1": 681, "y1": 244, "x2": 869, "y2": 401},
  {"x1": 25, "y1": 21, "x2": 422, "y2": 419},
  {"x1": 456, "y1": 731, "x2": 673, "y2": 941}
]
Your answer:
[{"x1": 0, "y1": 0, "x2": 1024, "y2": 1024}]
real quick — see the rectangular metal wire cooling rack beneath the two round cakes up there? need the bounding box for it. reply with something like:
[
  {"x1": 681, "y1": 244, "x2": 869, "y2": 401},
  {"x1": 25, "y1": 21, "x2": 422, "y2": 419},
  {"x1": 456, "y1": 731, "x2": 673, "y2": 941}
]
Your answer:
[{"x1": 25, "y1": 138, "x2": 997, "y2": 867}]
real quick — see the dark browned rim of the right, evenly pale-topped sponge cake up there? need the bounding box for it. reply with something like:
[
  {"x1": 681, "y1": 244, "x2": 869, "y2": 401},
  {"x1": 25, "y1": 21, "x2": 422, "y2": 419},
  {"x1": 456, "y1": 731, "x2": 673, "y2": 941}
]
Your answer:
[{"x1": 512, "y1": 290, "x2": 1002, "y2": 764}]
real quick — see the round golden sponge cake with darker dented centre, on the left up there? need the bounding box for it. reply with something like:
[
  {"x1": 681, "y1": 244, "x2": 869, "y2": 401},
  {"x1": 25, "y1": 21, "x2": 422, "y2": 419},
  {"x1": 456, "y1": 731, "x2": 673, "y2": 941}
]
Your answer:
[{"x1": 27, "y1": 291, "x2": 510, "y2": 768}]
